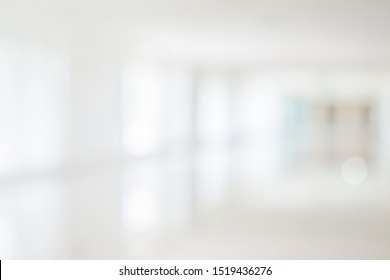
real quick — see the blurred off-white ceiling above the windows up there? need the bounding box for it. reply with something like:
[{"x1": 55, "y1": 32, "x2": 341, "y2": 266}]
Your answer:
[{"x1": 0, "y1": 0, "x2": 390, "y2": 67}]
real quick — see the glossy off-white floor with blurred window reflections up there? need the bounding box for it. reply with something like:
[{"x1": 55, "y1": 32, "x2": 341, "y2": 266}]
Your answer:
[{"x1": 0, "y1": 152, "x2": 390, "y2": 259}]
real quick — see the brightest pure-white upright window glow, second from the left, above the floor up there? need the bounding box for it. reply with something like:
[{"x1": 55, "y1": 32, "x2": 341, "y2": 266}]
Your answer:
[{"x1": 122, "y1": 63, "x2": 164, "y2": 156}]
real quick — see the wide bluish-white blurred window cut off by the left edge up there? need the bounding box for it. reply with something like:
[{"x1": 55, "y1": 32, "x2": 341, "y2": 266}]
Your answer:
[{"x1": 0, "y1": 46, "x2": 65, "y2": 173}]
